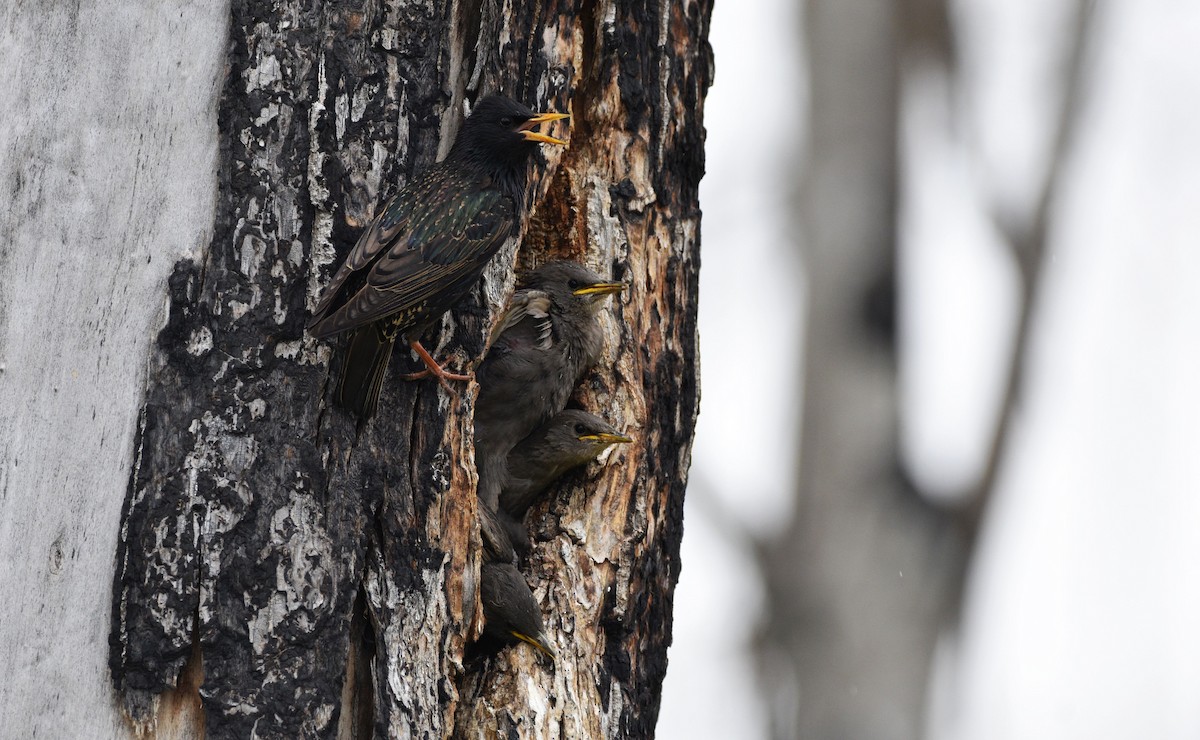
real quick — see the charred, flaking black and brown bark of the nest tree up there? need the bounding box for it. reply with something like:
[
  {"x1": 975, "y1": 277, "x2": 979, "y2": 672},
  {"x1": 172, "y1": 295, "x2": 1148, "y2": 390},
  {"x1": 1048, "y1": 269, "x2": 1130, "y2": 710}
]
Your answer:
[{"x1": 110, "y1": 0, "x2": 713, "y2": 738}]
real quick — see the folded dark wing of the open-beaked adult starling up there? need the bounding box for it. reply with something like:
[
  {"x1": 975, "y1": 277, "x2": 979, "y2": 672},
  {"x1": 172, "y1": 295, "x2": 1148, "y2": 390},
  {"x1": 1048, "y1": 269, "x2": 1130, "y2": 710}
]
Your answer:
[{"x1": 312, "y1": 170, "x2": 515, "y2": 337}]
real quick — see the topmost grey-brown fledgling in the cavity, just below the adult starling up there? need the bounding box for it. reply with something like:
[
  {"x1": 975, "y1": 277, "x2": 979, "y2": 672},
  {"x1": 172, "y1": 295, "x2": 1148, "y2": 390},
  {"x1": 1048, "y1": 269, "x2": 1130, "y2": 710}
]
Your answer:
[{"x1": 475, "y1": 261, "x2": 624, "y2": 509}]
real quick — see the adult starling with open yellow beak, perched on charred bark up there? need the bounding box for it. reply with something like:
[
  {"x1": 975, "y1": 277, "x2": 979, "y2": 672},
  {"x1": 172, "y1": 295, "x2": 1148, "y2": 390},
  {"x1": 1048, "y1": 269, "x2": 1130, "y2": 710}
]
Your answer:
[{"x1": 308, "y1": 96, "x2": 568, "y2": 419}]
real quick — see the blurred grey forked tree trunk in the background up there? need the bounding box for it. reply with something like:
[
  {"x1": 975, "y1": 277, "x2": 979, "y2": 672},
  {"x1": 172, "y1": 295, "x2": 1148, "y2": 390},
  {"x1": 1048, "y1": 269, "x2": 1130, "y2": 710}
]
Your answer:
[{"x1": 760, "y1": 0, "x2": 1088, "y2": 740}]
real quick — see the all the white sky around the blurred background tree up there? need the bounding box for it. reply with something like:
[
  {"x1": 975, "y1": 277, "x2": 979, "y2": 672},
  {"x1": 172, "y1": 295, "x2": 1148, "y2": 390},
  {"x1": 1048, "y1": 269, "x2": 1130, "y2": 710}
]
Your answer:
[{"x1": 659, "y1": 0, "x2": 1200, "y2": 740}]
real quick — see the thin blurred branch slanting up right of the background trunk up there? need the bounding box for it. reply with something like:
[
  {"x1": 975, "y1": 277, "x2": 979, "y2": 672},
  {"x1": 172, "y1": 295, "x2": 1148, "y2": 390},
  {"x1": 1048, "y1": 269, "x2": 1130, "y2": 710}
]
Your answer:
[{"x1": 956, "y1": 0, "x2": 1096, "y2": 542}]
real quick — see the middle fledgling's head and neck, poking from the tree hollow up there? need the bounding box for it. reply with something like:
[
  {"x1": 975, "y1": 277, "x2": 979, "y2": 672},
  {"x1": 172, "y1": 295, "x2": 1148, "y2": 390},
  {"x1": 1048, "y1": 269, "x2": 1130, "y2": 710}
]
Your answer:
[{"x1": 500, "y1": 409, "x2": 634, "y2": 520}]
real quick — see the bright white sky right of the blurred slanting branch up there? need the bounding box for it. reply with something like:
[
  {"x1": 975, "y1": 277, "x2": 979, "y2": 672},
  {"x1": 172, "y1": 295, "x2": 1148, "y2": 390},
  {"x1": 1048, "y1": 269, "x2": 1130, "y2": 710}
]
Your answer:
[{"x1": 918, "y1": 0, "x2": 1200, "y2": 740}]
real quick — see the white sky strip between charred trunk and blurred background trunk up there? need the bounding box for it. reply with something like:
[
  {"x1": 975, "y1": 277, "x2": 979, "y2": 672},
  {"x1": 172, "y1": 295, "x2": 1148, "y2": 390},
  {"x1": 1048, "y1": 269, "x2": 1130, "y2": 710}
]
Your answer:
[{"x1": 658, "y1": 0, "x2": 804, "y2": 740}]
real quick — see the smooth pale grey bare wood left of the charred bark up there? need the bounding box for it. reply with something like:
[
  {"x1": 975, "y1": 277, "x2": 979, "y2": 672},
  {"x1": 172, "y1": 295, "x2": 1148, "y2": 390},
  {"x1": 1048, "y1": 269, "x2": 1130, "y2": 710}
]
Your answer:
[{"x1": 0, "y1": 1, "x2": 228, "y2": 739}]
